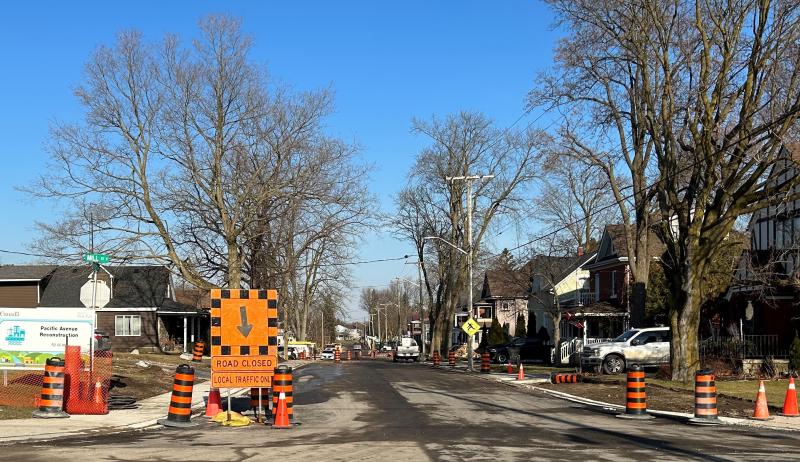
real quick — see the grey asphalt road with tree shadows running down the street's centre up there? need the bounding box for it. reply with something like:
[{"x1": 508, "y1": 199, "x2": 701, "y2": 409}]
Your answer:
[{"x1": 6, "y1": 360, "x2": 800, "y2": 462}]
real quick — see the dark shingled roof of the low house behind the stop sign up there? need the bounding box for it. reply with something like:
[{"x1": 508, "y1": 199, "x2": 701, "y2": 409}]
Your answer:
[{"x1": 39, "y1": 266, "x2": 170, "y2": 309}]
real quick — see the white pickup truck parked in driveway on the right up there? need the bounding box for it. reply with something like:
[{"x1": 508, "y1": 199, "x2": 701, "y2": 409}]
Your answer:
[{"x1": 581, "y1": 327, "x2": 670, "y2": 374}]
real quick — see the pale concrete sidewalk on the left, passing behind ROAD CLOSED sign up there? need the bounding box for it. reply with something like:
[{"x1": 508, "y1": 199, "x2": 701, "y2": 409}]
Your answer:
[{"x1": 0, "y1": 361, "x2": 308, "y2": 445}]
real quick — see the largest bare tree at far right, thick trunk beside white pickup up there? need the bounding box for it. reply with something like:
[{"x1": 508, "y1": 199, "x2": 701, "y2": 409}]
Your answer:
[{"x1": 536, "y1": 0, "x2": 800, "y2": 381}]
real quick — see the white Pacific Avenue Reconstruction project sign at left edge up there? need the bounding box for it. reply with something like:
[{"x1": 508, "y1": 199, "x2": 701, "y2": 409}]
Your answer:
[{"x1": 0, "y1": 308, "x2": 94, "y2": 367}]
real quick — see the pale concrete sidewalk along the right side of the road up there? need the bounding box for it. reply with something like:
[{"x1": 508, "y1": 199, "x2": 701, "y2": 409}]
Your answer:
[{"x1": 432, "y1": 362, "x2": 800, "y2": 431}]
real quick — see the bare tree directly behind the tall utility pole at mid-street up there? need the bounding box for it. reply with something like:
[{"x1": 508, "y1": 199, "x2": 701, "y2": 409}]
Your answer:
[{"x1": 399, "y1": 112, "x2": 541, "y2": 350}]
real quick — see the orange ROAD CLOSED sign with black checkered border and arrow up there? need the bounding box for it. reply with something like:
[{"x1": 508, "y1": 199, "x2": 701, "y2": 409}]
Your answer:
[{"x1": 211, "y1": 289, "x2": 278, "y2": 388}]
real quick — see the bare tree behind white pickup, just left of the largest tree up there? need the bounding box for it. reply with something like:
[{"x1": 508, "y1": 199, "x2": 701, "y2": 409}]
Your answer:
[{"x1": 529, "y1": 0, "x2": 655, "y2": 325}]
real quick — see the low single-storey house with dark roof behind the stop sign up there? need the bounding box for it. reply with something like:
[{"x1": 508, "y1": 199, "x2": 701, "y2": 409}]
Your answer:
[{"x1": 0, "y1": 265, "x2": 207, "y2": 351}]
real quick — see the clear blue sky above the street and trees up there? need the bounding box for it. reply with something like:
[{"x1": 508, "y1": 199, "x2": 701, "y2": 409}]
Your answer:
[{"x1": 0, "y1": 0, "x2": 557, "y2": 317}]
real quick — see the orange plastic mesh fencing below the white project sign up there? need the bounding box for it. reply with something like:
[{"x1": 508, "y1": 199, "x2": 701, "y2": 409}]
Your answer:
[{"x1": 0, "y1": 347, "x2": 112, "y2": 414}]
